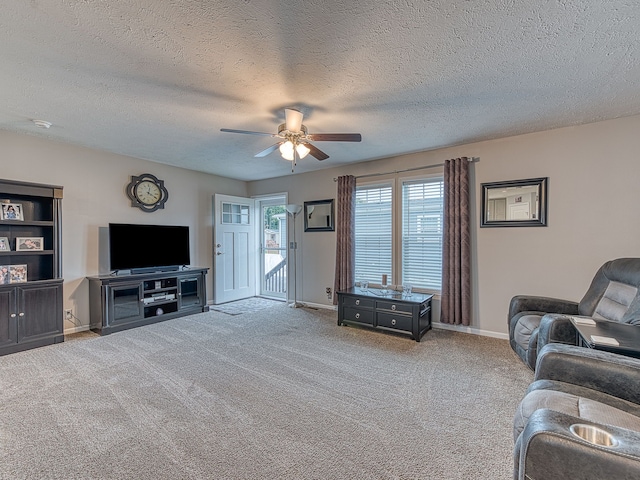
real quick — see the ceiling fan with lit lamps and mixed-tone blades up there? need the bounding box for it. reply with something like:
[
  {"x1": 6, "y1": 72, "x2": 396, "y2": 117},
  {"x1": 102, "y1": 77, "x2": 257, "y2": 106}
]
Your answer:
[{"x1": 220, "y1": 108, "x2": 362, "y2": 172}]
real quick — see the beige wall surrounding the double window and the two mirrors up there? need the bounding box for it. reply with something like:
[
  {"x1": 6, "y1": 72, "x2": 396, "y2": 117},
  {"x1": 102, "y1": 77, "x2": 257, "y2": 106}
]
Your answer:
[{"x1": 249, "y1": 116, "x2": 640, "y2": 336}]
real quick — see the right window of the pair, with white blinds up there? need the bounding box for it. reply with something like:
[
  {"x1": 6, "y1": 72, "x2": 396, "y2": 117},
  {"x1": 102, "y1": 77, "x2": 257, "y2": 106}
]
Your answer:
[{"x1": 402, "y1": 178, "x2": 444, "y2": 290}]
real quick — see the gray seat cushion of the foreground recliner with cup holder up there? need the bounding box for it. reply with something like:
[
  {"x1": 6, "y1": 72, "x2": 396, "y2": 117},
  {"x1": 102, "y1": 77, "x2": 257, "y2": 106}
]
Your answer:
[{"x1": 513, "y1": 390, "x2": 640, "y2": 440}]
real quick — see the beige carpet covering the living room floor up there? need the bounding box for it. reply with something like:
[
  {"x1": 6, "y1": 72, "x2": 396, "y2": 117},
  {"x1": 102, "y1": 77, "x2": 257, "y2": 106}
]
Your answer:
[{"x1": 0, "y1": 305, "x2": 532, "y2": 479}]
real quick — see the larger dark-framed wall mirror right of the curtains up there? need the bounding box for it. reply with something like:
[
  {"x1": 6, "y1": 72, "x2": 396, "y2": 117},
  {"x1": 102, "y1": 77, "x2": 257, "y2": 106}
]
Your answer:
[{"x1": 480, "y1": 177, "x2": 549, "y2": 227}]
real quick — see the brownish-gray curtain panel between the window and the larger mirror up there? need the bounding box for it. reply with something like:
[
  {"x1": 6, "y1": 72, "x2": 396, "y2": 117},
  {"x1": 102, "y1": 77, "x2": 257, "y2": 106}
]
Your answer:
[{"x1": 440, "y1": 157, "x2": 471, "y2": 325}]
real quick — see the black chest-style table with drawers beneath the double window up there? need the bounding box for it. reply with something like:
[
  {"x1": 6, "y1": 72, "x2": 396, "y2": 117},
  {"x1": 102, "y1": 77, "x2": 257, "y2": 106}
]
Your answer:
[{"x1": 338, "y1": 287, "x2": 433, "y2": 342}]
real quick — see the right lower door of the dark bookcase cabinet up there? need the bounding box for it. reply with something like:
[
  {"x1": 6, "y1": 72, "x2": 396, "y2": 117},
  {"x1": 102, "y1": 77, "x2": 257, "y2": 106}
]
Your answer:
[{"x1": 16, "y1": 285, "x2": 62, "y2": 343}]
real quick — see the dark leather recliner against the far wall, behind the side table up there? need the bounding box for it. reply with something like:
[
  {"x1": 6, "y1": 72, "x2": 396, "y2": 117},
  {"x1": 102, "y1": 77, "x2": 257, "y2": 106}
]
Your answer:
[{"x1": 508, "y1": 258, "x2": 640, "y2": 370}]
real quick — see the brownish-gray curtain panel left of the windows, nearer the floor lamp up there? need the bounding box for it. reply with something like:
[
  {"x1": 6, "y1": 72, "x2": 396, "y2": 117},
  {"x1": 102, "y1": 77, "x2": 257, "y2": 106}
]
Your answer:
[{"x1": 333, "y1": 175, "x2": 356, "y2": 305}]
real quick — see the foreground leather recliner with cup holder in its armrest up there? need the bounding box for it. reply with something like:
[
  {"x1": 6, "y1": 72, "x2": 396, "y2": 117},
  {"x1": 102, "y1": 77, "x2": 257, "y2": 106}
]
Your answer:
[{"x1": 513, "y1": 344, "x2": 640, "y2": 480}]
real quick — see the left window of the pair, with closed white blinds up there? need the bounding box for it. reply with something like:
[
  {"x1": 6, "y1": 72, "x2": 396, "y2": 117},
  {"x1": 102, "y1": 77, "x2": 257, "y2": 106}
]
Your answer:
[{"x1": 355, "y1": 185, "x2": 393, "y2": 283}]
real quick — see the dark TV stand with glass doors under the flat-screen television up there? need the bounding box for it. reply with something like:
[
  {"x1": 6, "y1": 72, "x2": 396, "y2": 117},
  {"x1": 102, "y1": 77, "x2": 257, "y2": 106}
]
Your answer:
[{"x1": 88, "y1": 268, "x2": 209, "y2": 335}]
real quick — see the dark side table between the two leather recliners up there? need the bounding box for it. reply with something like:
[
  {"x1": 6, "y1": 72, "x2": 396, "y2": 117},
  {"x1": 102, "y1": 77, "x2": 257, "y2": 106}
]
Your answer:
[{"x1": 571, "y1": 317, "x2": 640, "y2": 358}]
